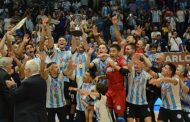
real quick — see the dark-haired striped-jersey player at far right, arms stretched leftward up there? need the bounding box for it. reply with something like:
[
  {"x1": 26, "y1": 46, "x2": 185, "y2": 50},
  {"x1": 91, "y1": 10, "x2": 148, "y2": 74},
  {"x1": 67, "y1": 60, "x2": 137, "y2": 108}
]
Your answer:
[{"x1": 149, "y1": 63, "x2": 183, "y2": 122}]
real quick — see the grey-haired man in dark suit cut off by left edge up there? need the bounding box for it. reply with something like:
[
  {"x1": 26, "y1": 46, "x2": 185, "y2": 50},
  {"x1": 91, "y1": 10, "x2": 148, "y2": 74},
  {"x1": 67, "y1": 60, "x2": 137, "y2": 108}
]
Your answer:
[{"x1": 0, "y1": 57, "x2": 13, "y2": 122}]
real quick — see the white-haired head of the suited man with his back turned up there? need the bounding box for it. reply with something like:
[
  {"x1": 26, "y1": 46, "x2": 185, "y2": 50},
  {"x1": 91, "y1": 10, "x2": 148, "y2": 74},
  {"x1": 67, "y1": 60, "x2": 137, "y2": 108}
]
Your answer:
[{"x1": 24, "y1": 60, "x2": 40, "y2": 77}]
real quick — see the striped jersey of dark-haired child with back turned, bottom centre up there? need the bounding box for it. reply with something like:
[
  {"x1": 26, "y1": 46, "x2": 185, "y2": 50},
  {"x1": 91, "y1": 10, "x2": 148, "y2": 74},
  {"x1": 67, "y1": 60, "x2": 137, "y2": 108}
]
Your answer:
[{"x1": 94, "y1": 95, "x2": 113, "y2": 122}]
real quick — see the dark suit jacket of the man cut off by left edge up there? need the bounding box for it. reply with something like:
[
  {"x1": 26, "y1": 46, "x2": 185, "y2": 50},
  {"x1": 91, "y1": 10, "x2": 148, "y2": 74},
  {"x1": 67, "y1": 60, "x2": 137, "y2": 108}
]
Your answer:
[{"x1": 0, "y1": 68, "x2": 13, "y2": 122}]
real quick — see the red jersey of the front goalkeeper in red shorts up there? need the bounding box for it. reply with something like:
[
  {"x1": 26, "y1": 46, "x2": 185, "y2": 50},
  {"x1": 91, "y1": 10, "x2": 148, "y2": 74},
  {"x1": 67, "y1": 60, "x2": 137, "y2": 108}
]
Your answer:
[{"x1": 106, "y1": 57, "x2": 127, "y2": 90}]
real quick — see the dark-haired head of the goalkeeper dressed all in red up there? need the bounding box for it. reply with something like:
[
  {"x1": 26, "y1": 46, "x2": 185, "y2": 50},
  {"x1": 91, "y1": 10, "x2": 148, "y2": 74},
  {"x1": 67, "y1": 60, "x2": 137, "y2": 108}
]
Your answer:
[{"x1": 109, "y1": 44, "x2": 121, "y2": 59}]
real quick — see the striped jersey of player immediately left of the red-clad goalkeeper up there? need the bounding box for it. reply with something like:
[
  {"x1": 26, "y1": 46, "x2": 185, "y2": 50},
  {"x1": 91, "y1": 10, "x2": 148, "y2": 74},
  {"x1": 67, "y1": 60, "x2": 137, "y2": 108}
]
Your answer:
[{"x1": 92, "y1": 58, "x2": 108, "y2": 84}]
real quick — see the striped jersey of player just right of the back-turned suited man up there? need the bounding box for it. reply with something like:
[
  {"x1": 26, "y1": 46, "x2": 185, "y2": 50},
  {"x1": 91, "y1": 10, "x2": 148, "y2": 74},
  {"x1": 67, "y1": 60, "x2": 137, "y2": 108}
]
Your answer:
[{"x1": 46, "y1": 72, "x2": 66, "y2": 108}]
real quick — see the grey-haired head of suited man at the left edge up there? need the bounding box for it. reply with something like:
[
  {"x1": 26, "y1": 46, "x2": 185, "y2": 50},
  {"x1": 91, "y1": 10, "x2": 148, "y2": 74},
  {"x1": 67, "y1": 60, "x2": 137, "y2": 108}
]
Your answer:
[{"x1": 0, "y1": 57, "x2": 13, "y2": 74}]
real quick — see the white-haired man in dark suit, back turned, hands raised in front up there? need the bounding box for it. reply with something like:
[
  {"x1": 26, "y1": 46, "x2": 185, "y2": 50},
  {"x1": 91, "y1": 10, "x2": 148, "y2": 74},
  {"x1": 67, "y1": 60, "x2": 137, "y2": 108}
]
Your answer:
[{"x1": 6, "y1": 60, "x2": 47, "y2": 122}]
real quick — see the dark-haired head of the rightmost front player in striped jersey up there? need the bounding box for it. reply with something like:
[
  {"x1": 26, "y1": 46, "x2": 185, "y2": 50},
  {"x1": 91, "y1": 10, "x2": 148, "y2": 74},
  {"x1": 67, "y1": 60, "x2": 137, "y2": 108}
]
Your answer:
[{"x1": 162, "y1": 63, "x2": 176, "y2": 77}]
